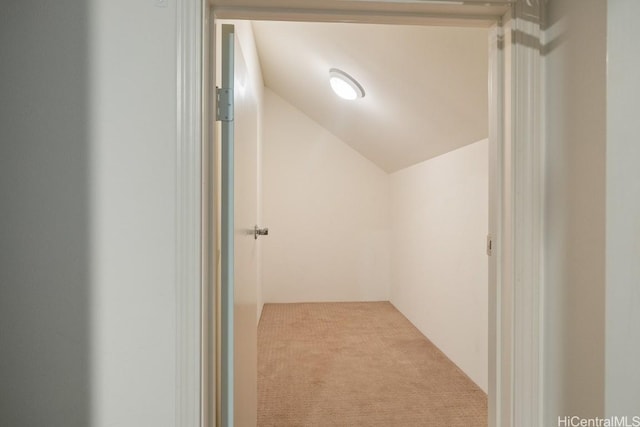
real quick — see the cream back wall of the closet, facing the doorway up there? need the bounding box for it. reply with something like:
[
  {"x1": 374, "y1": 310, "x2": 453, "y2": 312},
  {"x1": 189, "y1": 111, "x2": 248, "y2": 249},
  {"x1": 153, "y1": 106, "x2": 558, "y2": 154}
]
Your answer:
[{"x1": 263, "y1": 89, "x2": 389, "y2": 302}]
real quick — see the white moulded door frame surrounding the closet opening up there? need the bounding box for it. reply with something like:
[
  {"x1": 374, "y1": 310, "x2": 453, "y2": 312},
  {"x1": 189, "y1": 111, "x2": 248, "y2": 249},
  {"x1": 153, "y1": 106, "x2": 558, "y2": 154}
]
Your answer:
[{"x1": 176, "y1": 0, "x2": 544, "y2": 427}]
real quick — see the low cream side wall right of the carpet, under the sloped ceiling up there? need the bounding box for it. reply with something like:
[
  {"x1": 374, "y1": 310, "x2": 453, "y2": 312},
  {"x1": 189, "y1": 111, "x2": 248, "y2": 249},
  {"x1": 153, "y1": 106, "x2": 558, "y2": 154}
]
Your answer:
[{"x1": 390, "y1": 140, "x2": 489, "y2": 391}]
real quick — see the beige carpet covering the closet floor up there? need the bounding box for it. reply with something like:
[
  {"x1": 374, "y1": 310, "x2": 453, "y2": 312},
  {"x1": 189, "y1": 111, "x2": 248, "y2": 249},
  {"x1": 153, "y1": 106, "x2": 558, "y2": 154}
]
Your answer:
[{"x1": 258, "y1": 302, "x2": 487, "y2": 427}]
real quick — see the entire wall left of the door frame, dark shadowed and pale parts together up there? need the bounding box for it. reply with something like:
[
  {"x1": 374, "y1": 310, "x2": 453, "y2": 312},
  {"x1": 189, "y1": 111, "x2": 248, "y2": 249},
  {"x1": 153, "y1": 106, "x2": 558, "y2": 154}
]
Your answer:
[{"x1": 0, "y1": 0, "x2": 176, "y2": 427}]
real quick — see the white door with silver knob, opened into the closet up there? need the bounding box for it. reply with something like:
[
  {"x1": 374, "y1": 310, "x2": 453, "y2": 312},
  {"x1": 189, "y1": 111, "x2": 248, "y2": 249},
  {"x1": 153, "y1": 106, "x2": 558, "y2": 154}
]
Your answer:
[{"x1": 221, "y1": 25, "x2": 259, "y2": 427}]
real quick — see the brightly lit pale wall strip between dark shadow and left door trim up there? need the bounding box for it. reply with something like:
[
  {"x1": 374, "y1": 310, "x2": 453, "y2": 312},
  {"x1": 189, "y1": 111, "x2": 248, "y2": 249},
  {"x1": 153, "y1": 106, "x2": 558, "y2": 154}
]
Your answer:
[{"x1": 90, "y1": 0, "x2": 176, "y2": 427}]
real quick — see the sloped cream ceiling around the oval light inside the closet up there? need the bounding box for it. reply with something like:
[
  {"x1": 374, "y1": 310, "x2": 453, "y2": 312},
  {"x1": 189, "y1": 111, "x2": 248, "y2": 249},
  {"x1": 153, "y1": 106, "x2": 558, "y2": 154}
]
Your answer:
[{"x1": 253, "y1": 21, "x2": 488, "y2": 172}]
